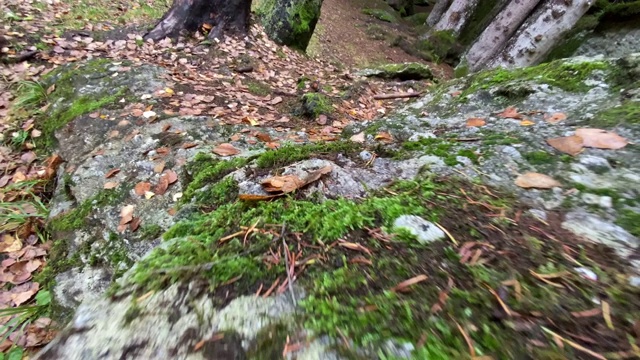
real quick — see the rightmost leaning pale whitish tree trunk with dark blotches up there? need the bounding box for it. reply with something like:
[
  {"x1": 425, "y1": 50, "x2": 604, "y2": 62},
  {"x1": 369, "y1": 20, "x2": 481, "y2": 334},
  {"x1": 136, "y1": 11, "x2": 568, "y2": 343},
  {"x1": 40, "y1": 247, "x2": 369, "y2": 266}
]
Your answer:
[{"x1": 486, "y1": 0, "x2": 592, "y2": 68}]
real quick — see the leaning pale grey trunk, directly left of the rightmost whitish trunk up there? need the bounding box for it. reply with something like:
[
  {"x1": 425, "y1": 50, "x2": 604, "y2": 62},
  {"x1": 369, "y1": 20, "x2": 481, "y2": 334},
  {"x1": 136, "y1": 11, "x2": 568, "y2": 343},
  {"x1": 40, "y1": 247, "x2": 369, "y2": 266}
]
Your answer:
[{"x1": 465, "y1": 0, "x2": 540, "y2": 72}]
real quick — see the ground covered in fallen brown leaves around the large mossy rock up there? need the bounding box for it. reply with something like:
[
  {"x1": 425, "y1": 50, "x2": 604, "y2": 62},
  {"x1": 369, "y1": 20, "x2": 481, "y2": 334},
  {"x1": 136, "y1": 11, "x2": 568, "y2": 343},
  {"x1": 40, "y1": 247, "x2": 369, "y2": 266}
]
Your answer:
[{"x1": 0, "y1": 0, "x2": 440, "y2": 359}]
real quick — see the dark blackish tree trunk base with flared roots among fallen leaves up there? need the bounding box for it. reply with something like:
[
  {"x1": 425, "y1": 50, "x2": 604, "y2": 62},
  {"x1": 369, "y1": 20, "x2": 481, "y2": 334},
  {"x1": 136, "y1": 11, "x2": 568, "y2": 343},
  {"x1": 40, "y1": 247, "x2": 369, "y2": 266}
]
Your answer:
[{"x1": 145, "y1": 0, "x2": 251, "y2": 40}]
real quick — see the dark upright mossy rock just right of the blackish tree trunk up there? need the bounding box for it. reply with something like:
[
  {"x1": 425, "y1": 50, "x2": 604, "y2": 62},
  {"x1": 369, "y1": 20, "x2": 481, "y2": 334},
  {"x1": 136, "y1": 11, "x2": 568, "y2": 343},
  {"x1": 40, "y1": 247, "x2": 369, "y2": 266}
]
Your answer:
[{"x1": 256, "y1": 0, "x2": 322, "y2": 51}]
